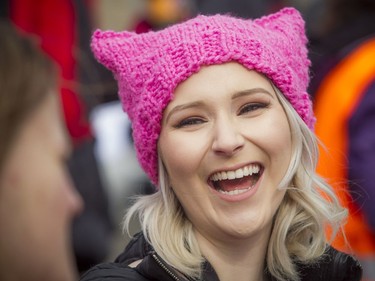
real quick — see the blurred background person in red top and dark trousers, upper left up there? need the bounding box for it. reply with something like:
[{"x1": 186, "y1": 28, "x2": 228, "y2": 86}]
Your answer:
[{"x1": 0, "y1": 0, "x2": 116, "y2": 271}]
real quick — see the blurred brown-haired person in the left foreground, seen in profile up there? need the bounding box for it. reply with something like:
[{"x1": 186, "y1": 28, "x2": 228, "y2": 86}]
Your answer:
[{"x1": 0, "y1": 21, "x2": 82, "y2": 281}]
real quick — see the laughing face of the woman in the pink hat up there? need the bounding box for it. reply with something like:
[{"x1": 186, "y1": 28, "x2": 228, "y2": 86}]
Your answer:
[{"x1": 158, "y1": 63, "x2": 292, "y2": 241}]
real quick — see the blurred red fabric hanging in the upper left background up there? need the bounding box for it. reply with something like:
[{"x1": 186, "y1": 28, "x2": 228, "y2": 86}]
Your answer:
[{"x1": 10, "y1": 0, "x2": 91, "y2": 143}]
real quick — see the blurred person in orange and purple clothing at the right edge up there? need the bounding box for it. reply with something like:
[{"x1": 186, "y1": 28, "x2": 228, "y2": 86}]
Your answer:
[{"x1": 311, "y1": 0, "x2": 375, "y2": 280}]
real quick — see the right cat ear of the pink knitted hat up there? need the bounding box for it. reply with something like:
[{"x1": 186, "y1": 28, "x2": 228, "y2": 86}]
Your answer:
[{"x1": 254, "y1": 8, "x2": 307, "y2": 43}]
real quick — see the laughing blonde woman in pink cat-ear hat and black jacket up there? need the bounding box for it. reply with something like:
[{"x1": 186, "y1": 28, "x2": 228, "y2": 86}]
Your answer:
[{"x1": 82, "y1": 8, "x2": 361, "y2": 281}]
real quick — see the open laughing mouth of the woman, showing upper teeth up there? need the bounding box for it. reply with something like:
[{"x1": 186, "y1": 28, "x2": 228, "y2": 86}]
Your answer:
[{"x1": 209, "y1": 164, "x2": 263, "y2": 195}]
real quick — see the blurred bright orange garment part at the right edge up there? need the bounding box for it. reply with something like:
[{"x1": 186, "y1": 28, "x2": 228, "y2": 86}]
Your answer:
[{"x1": 314, "y1": 36, "x2": 375, "y2": 254}]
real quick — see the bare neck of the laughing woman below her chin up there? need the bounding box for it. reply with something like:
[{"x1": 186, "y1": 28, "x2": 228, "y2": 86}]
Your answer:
[{"x1": 196, "y1": 228, "x2": 269, "y2": 281}]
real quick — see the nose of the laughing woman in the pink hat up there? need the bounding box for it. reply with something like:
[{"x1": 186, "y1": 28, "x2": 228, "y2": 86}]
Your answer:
[{"x1": 212, "y1": 116, "x2": 245, "y2": 156}]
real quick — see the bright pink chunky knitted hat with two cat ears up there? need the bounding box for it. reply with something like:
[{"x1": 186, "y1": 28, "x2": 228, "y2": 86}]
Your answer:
[{"x1": 91, "y1": 8, "x2": 315, "y2": 185}]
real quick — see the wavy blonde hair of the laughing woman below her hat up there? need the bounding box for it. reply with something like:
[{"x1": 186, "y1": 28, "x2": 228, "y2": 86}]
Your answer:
[{"x1": 124, "y1": 87, "x2": 347, "y2": 281}]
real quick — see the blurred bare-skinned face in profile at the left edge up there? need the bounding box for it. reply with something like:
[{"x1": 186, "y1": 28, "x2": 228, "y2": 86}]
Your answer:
[{"x1": 0, "y1": 92, "x2": 82, "y2": 281}]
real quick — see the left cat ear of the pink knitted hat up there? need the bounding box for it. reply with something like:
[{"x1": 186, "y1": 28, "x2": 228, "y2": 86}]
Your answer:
[{"x1": 91, "y1": 29, "x2": 136, "y2": 73}]
